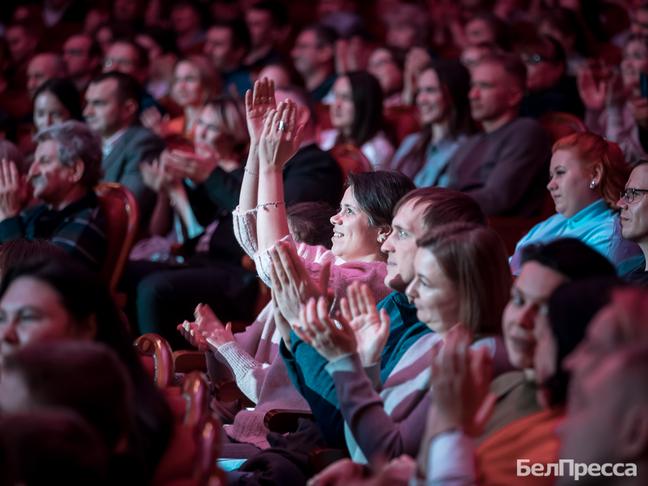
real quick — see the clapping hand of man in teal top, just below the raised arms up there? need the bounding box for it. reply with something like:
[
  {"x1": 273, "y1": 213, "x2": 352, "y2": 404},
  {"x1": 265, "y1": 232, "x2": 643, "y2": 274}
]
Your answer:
[{"x1": 270, "y1": 241, "x2": 331, "y2": 322}]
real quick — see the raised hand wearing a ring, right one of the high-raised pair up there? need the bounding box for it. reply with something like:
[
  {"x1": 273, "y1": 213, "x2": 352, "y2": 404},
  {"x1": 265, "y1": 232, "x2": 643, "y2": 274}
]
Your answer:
[{"x1": 259, "y1": 100, "x2": 303, "y2": 172}]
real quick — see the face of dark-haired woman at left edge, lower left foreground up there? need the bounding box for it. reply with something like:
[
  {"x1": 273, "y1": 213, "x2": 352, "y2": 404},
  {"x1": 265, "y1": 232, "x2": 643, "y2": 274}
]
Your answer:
[{"x1": 0, "y1": 276, "x2": 74, "y2": 363}]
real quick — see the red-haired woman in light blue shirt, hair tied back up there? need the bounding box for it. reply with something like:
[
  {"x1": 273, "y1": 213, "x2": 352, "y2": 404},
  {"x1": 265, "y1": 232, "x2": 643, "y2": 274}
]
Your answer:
[{"x1": 511, "y1": 133, "x2": 639, "y2": 274}]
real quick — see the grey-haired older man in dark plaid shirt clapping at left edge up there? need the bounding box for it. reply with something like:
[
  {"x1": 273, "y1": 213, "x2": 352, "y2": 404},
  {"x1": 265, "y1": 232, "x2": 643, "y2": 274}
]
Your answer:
[{"x1": 0, "y1": 121, "x2": 107, "y2": 270}]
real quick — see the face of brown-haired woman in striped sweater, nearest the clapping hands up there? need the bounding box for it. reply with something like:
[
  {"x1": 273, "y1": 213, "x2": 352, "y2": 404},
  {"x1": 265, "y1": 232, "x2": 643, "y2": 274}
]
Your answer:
[{"x1": 406, "y1": 248, "x2": 459, "y2": 332}]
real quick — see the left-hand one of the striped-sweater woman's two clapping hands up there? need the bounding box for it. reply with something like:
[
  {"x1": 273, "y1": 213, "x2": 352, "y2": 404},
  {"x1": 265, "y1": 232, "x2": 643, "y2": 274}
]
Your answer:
[{"x1": 293, "y1": 297, "x2": 358, "y2": 361}]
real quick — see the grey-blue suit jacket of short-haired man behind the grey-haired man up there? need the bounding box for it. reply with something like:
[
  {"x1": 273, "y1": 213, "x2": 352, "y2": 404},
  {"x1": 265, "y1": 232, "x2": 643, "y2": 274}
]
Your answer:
[{"x1": 101, "y1": 125, "x2": 164, "y2": 221}]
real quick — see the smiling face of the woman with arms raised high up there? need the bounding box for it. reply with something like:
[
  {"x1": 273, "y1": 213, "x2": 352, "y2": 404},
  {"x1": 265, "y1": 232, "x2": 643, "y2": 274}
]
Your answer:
[{"x1": 331, "y1": 187, "x2": 381, "y2": 261}]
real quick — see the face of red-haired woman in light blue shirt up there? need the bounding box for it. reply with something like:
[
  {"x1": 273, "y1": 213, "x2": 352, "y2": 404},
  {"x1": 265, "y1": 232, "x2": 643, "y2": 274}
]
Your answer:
[{"x1": 547, "y1": 149, "x2": 600, "y2": 218}]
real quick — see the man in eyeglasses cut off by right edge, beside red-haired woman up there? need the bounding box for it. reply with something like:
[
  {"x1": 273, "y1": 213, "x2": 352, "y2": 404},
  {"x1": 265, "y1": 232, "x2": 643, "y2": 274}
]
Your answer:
[{"x1": 617, "y1": 160, "x2": 648, "y2": 285}]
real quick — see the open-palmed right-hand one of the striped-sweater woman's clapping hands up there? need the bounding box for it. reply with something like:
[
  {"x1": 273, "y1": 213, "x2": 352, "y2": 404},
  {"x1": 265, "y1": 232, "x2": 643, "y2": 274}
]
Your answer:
[{"x1": 340, "y1": 282, "x2": 390, "y2": 367}]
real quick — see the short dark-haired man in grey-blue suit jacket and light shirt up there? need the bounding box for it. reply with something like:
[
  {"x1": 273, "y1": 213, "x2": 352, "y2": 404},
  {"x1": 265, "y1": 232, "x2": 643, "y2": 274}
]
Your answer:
[{"x1": 83, "y1": 71, "x2": 164, "y2": 221}]
